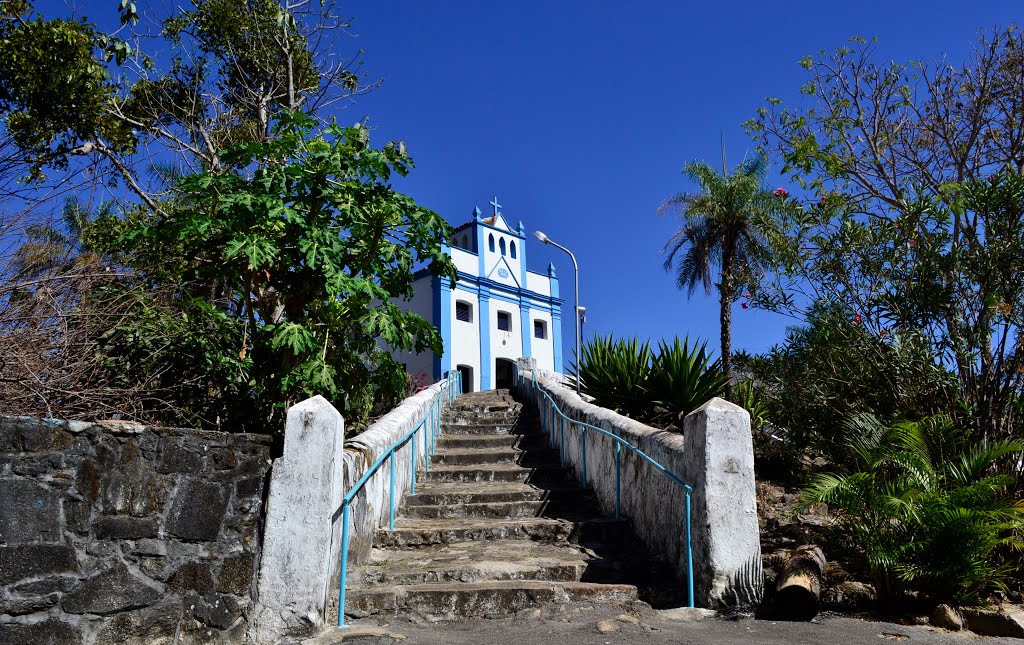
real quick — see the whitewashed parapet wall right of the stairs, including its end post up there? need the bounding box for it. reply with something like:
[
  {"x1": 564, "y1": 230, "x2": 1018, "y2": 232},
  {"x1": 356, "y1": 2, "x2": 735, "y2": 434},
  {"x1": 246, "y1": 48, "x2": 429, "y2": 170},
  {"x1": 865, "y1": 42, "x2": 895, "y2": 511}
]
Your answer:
[{"x1": 518, "y1": 371, "x2": 762, "y2": 608}]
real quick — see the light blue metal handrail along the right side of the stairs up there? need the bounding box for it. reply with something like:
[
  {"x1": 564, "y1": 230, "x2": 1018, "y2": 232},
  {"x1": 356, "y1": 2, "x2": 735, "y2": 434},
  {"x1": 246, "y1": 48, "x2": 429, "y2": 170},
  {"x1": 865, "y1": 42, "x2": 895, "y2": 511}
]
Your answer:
[{"x1": 513, "y1": 369, "x2": 693, "y2": 607}]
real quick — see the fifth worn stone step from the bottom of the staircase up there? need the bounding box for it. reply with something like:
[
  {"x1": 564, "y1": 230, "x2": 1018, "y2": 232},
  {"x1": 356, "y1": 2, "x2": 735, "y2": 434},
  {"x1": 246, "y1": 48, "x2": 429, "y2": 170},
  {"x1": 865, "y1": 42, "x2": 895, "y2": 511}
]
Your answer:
[{"x1": 406, "y1": 481, "x2": 591, "y2": 507}]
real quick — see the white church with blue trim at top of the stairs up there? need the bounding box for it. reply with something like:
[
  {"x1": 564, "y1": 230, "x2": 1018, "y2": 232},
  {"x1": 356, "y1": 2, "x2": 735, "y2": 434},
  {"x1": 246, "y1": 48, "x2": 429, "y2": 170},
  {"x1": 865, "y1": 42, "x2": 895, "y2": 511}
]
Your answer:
[{"x1": 394, "y1": 198, "x2": 562, "y2": 392}]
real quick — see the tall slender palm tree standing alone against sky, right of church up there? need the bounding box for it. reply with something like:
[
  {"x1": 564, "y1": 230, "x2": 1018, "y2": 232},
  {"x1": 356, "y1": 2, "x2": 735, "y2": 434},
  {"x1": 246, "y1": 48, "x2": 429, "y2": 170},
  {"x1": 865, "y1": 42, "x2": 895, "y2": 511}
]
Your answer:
[{"x1": 658, "y1": 154, "x2": 784, "y2": 398}]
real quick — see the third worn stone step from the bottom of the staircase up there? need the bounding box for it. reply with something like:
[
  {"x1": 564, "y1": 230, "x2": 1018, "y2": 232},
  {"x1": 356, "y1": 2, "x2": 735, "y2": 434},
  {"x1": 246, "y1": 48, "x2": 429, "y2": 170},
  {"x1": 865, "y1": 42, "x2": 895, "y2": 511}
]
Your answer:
[{"x1": 374, "y1": 514, "x2": 633, "y2": 549}]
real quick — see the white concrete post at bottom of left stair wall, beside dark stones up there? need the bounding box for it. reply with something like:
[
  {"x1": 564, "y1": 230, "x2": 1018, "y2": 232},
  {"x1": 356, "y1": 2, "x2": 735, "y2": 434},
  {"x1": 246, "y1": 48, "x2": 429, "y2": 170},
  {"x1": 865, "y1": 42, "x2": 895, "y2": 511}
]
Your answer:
[{"x1": 249, "y1": 396, "x2": 345, "y2": 643}]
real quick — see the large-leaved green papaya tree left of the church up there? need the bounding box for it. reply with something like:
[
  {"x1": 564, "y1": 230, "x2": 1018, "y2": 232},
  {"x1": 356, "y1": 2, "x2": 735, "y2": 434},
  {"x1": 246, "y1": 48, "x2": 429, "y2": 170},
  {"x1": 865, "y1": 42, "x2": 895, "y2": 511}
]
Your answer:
[{"x1": 121, "y1": 114, "x2": 455, "y2": 427}]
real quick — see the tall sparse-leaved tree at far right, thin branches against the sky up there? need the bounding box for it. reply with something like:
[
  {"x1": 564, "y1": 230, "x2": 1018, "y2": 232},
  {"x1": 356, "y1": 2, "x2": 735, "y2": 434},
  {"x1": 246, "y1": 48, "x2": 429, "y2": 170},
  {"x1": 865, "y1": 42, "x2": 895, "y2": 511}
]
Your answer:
[{"x1": 748, "y1": 27, "x2": 1024, "y2": 456}]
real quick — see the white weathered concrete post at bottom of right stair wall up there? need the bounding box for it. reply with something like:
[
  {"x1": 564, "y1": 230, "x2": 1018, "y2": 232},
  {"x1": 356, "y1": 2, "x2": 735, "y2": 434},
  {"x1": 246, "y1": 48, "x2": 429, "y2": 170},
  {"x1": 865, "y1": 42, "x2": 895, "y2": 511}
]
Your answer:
[{"x1": 683, "y1": 398, "x2": 763, "y2": 608}]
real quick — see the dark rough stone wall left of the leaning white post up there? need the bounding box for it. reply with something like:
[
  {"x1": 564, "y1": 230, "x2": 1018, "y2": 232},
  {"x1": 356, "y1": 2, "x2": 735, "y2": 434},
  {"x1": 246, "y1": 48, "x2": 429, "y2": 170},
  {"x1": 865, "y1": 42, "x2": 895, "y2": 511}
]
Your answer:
[{"x1": 0, "y1": 418, "x2": 270, "y2": 645}]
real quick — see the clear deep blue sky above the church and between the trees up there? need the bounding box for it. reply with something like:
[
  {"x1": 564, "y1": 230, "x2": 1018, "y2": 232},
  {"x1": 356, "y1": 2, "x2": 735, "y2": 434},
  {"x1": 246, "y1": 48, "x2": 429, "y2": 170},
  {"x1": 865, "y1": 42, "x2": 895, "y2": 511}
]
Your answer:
[{"x1": 339, "y1": 0, "x2": 1022, "y2": 364}]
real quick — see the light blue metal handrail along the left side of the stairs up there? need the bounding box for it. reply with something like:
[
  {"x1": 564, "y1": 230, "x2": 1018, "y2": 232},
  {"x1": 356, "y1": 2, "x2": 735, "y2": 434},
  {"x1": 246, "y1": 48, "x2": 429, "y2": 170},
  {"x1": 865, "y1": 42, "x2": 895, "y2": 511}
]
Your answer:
[{"x1": 335, "y1": 370, "x2": 462, "y2": 628}]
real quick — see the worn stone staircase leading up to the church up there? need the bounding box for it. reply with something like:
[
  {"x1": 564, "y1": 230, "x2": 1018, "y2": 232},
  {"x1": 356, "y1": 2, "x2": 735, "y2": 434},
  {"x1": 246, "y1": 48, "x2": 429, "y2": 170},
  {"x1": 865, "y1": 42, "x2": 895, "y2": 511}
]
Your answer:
[{"x1": 345, "y1": 390, "x2": 686, "y2": 621}]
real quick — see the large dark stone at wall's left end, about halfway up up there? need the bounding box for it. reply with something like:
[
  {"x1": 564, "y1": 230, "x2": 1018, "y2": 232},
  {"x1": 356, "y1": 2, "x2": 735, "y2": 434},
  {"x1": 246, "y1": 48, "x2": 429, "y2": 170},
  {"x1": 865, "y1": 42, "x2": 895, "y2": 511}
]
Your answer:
[{"x1": 0, "y1": 479, "x2": 60, "y2": 544}]
